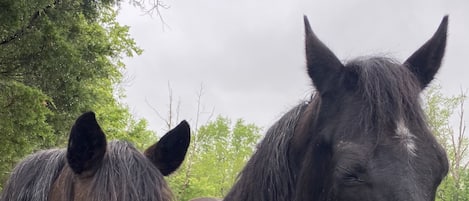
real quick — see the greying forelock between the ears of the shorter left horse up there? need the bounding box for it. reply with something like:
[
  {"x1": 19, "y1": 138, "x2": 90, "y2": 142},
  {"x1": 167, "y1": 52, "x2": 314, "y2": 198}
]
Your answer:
[{"x1": 99, "y1": 141, "x2": 173, "y2": 201}]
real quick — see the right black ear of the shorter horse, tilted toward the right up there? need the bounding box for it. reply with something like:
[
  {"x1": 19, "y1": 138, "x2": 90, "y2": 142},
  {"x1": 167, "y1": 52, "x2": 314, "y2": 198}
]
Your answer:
[{"x1": 145, "y1": 121, "x2": 191, "y2": 176}]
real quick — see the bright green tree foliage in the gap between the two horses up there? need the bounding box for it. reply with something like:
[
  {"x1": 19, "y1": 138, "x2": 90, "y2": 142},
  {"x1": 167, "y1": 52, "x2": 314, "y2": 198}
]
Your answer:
[{"x1": 169, "y1": 117, "x2": 261, "y2": 200}]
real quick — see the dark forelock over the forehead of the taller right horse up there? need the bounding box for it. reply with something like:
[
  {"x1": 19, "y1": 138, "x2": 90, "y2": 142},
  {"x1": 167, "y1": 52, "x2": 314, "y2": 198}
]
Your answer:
[{"x1": 346, "y1": 57, "x2": 433, "y2": 152}]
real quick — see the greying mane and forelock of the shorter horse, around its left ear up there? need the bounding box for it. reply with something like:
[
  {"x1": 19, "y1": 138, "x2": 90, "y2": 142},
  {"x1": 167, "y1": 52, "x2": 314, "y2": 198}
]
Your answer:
[{"x1": 0, "y1": 141, "x2": 173, "y2": 201}]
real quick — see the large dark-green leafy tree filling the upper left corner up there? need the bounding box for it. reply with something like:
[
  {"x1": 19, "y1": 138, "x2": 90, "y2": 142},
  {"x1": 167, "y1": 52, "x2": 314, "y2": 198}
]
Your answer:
[{"x1": 0, "y1": 0, "x2": 141, "y2": 140}]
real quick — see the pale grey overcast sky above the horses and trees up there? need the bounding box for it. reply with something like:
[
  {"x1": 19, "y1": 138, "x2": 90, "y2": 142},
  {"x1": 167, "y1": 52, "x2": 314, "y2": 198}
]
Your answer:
[{"x1": 118, "y1": 0, "x2": 469, "y2": 135}]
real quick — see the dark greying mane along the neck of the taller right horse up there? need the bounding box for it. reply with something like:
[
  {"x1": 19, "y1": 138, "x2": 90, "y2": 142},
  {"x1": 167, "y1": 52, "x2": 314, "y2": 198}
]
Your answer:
[{"x1": 224, "y1": 104, "x2": 307, "y2": 201}]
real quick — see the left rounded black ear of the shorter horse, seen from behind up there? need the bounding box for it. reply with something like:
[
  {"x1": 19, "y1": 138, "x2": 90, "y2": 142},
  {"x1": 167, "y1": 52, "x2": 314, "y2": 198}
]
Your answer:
[{"x1": 67, "y1": 112, "x2": 106, "y2": 174}]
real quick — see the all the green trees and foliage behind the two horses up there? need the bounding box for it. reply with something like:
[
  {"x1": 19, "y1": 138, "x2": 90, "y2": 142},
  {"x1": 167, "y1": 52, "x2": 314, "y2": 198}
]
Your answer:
[{"x1": 0, "y1": 0, "x2": 469, "y2": 201}]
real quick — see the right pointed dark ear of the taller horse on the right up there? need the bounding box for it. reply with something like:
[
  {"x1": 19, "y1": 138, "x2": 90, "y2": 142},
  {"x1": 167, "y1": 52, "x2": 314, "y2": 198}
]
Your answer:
[{"x1": 405, "y1": 16, "x2": 448, "y2": 89}]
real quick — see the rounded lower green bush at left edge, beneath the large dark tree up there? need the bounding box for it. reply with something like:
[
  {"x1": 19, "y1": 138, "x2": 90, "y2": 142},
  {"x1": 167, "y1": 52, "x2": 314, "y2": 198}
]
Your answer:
[{"x1": 0, "y1": 80, "x2": 53, "y2": 182}]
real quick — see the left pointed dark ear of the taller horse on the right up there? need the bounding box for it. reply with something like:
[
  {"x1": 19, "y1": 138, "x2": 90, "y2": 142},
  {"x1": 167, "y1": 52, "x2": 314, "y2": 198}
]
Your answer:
[{"x1": 304, "y1": 16, "x2": 343, "y2": 94}]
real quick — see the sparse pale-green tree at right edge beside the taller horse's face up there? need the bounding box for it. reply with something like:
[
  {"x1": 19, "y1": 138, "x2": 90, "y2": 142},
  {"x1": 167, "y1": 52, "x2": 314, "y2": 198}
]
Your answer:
[{"x1": 425, "y1": 86, "x2": 469, "y2": 201}]
